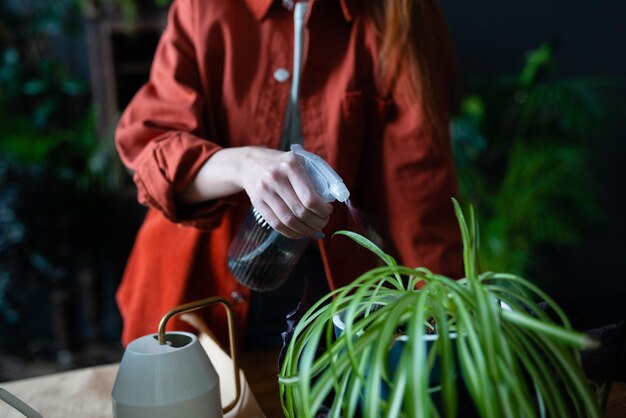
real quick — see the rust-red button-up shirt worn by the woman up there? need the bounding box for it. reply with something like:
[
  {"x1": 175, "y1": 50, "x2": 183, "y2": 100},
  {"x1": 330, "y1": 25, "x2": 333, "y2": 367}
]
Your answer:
[{"x1": 116, "y1": 0, "x2": 461, "y2": 343}]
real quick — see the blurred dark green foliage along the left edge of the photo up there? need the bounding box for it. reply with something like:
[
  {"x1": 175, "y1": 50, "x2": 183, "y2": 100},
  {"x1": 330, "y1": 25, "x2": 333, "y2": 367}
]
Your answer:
[{"x1": 0, "y1": 0, "x2": 125, "y2": 323}]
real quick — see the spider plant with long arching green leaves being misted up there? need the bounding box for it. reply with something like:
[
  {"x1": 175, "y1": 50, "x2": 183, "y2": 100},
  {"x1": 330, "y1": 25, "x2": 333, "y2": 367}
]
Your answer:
[{"x1": 279, "y1": 200, "x2": 601, "y2": 418}]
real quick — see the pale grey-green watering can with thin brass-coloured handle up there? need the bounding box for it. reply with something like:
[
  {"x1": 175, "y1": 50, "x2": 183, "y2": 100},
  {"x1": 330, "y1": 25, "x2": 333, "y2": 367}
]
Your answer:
[{"x1": 111, "y1": 297, "x2": 241, "y2": 418}]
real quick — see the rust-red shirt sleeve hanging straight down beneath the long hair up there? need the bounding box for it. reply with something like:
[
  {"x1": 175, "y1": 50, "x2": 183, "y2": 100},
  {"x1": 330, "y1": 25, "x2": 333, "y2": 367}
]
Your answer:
[{"x1": 368, "y1": 74, "x2": 463, "y2": 278}]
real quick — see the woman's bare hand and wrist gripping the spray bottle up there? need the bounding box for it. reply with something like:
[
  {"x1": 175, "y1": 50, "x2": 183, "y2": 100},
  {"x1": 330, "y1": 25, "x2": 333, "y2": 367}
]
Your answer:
[{"x1": 179, "y1": 147, "x2": 333, "y2": 238}]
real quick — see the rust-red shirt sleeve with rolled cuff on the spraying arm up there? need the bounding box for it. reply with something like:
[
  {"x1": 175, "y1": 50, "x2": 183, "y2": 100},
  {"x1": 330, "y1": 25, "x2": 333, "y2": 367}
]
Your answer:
[{"x1": 115, "y1": 0, "x2": 232, "y2": 229}]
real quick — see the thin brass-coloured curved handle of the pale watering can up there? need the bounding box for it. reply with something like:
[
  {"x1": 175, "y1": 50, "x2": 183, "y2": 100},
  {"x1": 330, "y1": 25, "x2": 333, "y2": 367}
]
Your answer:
[{"x1": 158, "y1": 297, "x2": 241, "y2": 414}]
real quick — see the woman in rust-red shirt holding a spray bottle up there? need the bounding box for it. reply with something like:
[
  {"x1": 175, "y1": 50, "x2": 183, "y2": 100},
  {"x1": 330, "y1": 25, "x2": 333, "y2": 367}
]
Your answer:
[{"x1": 116, "y1": 0, "x2": 461, "y2": 343}]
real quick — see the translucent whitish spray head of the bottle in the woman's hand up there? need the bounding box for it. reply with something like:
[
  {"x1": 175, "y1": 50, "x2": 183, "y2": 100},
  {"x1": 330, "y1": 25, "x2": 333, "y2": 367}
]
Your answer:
[{"x1": 291, "y1": 144, "x2": 350, "y2": 202}]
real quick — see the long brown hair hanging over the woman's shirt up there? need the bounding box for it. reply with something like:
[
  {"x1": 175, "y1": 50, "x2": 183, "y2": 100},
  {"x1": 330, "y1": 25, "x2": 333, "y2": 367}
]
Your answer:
[{"x1": 367, "y1": 0, "x2": 458, "y2": 138}]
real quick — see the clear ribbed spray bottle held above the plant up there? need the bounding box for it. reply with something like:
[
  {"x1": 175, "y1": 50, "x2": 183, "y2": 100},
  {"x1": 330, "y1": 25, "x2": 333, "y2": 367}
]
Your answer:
[{"x1": 228, "y1": 145, "x2": 350, "y2": 291}]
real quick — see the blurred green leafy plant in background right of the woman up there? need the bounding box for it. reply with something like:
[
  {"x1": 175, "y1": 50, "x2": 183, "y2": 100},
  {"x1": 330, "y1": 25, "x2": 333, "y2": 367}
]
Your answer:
[{"x1": 452, "y1": 43, "x2": 606, "y2": 274}]
